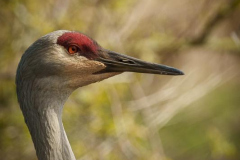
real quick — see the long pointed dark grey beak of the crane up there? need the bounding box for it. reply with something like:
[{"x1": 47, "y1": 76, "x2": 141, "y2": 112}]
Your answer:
[{"x1": 96, "y1": 51, "x2": 184, "y2": 75}]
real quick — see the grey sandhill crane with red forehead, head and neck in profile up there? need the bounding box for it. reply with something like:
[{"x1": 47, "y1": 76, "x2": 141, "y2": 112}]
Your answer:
[{"x1": 16, "y1": 30, "x2": 183, "y2": 160}]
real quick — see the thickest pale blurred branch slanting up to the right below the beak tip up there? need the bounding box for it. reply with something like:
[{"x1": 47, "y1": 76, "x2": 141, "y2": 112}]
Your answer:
[{"x1": 151, "y1": 69, "x2": 238, "y2": 128}]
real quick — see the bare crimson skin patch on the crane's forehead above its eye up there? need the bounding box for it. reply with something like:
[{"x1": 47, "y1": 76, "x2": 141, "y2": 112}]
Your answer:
[{"x1": 57, "y1": 32, "x2": 100, "y2": 59}]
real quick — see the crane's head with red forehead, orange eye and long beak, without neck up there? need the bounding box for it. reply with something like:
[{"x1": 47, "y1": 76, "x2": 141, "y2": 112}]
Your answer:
[{"x1": 15, "y1": 30, "x2": 183, "y2": 88}]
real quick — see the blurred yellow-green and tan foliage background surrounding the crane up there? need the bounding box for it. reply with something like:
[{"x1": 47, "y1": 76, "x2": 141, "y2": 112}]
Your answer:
[{"x1": 0, "y1": 0, "x2": 240, "y2": 160}]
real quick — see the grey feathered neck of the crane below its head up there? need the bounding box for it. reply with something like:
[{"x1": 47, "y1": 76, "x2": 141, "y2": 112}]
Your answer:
[{"x1": 17, "y1": 77, "x2": 75, "y2": 160}]
